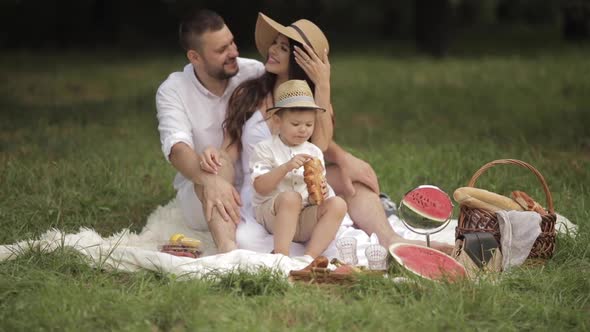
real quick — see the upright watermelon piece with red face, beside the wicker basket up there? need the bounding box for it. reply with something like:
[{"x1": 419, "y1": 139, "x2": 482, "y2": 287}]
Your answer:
[{"x1": 402, "y1": 185, "x2": 453, "y2": 223}]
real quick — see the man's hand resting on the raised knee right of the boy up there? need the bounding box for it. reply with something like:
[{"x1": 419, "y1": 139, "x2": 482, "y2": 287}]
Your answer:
[{"x1": 338, "y1": 153, "x2": 380, "y2": 196}]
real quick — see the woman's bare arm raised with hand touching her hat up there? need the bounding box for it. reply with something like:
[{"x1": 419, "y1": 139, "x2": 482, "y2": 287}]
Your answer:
[{"x1": 294, "y1": 44, "x2": 334, "y2": 151}]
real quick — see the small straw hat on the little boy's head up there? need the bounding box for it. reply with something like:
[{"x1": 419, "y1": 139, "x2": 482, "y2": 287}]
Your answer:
[{"x1": 266, "y1": 80, "x2": 326, "y2": 114}]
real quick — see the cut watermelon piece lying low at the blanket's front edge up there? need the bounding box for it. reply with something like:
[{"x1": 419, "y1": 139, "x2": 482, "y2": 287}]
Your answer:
[{"x1": 389, "y1": 243, "x2": 467, "y2": 281}]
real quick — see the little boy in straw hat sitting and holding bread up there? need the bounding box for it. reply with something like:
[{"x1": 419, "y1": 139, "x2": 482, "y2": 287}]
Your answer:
[{"x1": 250, "y1": 80, "x2": 347, "y2": 258}]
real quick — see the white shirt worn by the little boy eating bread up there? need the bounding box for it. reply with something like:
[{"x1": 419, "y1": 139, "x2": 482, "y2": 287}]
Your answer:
[{"x1": 250, "y1": 135, "x2": 326, "y2": 207}]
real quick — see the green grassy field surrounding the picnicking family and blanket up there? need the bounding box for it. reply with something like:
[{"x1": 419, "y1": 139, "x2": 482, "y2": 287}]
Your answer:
[{"x1": 0, "y1": 35, "x2": 590, "y2": 331}]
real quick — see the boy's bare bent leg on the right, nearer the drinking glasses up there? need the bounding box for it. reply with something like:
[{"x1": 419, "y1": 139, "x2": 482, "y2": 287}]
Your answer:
[{"x1": 305, "y1": 196, "x2": 346, "y2": 258}]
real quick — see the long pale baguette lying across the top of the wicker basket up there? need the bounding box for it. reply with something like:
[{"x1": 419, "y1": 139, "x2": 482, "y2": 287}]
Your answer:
[{"x1": 453, "y1": 187, "x2": 523, "y2": 212}]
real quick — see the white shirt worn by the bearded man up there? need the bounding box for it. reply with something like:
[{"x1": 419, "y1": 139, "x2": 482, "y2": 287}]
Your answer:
[{"x1": 156, "y1": 58, "x2": 264, "y2": 189}]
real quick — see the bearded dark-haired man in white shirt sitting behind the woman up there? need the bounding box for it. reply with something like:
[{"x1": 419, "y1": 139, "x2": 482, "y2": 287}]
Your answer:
[{"x1": 156, "y1": 10, "x2": 440, "y2": 252}]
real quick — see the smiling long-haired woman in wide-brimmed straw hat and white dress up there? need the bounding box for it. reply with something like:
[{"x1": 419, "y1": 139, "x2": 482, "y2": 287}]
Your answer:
[{"x1": 224, "y1": 14, "x2": 354, "y2": 255}]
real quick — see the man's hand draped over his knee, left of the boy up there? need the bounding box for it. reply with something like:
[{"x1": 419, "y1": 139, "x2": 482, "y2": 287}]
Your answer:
[{"x1": 201, "y1": 175, "x2": 242, "y2": 225}]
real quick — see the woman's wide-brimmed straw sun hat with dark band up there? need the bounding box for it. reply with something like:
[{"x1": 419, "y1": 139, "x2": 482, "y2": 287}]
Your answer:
[{"x1": 254, "y1": 13, "x2": 330, "y2": 58}]
